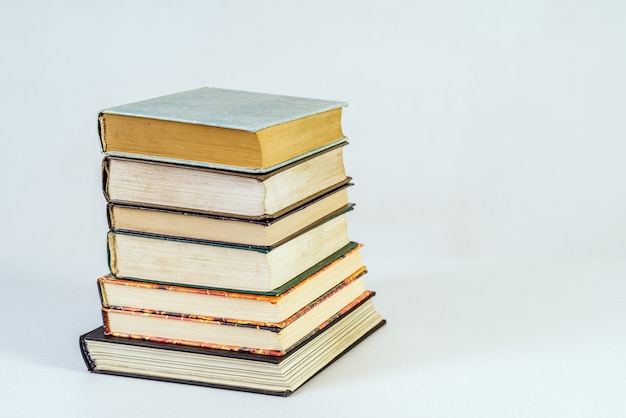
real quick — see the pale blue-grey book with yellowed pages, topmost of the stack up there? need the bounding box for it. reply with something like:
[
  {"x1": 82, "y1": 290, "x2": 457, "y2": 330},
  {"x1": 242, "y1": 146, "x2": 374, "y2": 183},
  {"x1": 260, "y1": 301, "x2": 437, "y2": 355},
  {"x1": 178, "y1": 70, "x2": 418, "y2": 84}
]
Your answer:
[{"x1": 98, "y1": 87, "x2": 347, "y2": 173}]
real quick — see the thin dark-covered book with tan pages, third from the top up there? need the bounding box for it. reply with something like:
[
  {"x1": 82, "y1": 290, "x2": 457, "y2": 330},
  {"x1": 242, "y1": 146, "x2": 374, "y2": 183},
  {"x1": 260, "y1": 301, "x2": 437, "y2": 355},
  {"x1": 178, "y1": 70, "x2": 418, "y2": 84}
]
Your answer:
[{"x1": 107, "y1": 183, "x2": 354, "y2": 248}]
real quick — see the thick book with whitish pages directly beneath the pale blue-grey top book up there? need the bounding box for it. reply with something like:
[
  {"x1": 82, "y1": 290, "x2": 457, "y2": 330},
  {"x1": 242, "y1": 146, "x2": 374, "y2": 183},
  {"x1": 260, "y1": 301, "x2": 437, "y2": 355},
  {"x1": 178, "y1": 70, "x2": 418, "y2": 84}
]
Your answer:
[{"x1": 102, "y1": 141, "x2": 350, "y2": 219}]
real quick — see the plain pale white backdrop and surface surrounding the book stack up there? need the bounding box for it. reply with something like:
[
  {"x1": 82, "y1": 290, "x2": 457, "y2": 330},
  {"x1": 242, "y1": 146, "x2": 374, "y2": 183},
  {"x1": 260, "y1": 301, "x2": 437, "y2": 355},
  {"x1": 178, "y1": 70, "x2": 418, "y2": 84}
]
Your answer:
[{"x1": 0, "y1": 0, "x2": 626, "y2": 417}]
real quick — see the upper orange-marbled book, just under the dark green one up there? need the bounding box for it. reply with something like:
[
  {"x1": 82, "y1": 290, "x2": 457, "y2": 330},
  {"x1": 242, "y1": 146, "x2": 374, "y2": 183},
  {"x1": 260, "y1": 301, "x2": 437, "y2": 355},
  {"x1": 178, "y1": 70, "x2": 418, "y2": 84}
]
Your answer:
[{"x1": 97, "y1": 245, "x2": 366, "y2": 322}]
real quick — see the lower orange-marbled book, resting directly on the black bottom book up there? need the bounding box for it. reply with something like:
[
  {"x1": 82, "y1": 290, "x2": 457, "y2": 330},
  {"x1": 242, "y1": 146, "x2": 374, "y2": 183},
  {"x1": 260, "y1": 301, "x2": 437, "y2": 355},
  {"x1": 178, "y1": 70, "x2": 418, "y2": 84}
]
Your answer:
[{"x1": 102, "y1": 276, "x2": 371, "y2": 356}]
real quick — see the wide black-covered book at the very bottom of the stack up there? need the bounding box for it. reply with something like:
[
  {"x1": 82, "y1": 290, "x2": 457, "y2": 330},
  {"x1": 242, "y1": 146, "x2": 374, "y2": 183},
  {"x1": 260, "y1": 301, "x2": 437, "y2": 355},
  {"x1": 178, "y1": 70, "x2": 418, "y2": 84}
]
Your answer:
[{"x1": 80, "y1": 298, "x2": 385, "y2": 396}]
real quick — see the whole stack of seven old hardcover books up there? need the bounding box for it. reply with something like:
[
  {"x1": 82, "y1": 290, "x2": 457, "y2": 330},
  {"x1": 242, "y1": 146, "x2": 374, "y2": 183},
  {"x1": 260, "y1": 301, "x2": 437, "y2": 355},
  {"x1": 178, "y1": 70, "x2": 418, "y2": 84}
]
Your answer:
[{"x1": 80, "y1": 88, "x2": 385, "y2": 395}]
